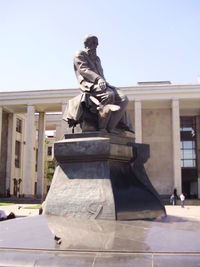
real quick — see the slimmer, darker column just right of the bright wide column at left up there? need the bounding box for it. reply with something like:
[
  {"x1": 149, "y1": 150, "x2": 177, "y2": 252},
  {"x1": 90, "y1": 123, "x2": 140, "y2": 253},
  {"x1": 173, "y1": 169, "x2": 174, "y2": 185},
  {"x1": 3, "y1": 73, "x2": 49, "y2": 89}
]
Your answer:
[{"x1": 37, "y1": 112, "x2": 45, "y2": 198}]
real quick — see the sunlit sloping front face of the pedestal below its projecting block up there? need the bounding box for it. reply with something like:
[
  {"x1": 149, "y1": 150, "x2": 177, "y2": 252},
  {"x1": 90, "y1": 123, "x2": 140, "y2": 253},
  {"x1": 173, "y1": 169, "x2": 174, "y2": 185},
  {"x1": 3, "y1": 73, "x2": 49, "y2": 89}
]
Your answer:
[{"x1": 45, "y1": 162, "x2": 115, "y2": 220}]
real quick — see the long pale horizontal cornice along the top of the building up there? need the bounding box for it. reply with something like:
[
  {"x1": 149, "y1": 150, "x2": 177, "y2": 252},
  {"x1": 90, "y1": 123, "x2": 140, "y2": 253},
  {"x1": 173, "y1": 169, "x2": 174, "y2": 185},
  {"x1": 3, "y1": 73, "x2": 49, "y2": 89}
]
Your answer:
[{"x1": 0, "y1": 84, "x2": 200, "y2": 112}]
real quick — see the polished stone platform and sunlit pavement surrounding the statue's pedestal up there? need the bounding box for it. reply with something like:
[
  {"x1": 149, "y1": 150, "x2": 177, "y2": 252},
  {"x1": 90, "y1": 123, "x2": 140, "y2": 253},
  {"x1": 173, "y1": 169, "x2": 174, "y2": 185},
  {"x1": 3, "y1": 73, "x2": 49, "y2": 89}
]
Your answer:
[{"x1": 0, "y1": 204, "x2": 200, "y2": 267}]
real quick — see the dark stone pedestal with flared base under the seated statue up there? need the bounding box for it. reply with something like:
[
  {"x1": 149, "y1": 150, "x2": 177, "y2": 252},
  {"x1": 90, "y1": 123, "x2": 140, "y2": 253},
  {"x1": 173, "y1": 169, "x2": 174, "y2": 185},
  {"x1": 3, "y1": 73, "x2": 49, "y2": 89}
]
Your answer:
[{"x1": 45, "y1": 132, "x2": 164, "y2": 220}]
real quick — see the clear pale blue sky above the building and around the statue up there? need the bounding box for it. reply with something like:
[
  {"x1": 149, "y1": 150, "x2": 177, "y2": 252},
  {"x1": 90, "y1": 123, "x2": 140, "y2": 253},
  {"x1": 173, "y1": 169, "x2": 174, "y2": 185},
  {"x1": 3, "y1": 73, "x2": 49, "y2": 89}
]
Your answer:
[{"x1": 0, "y1": 0, "x2": 200, "y2": 91}]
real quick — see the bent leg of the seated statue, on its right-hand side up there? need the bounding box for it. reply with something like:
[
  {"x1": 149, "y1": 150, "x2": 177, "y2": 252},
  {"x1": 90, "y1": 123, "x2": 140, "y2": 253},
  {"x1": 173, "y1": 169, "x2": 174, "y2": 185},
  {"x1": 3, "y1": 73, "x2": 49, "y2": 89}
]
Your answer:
[{"x1": 108, "y1": 88, "x2": 128, "y2": 131}]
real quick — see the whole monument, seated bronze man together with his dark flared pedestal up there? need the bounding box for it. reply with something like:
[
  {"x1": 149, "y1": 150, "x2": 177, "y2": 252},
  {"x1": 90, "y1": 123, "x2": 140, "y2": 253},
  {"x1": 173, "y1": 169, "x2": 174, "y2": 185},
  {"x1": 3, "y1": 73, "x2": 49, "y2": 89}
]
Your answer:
[{"x1": 45, "y1": 36, "x2": 166, "y2": 221}]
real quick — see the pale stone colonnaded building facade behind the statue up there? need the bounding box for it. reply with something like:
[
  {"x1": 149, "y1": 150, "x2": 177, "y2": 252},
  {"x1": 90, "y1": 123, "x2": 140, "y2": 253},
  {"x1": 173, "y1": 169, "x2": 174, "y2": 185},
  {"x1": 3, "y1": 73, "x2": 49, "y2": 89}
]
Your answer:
[{"x1": 0, "y1": 83, "x2": 200, "y2": 197}]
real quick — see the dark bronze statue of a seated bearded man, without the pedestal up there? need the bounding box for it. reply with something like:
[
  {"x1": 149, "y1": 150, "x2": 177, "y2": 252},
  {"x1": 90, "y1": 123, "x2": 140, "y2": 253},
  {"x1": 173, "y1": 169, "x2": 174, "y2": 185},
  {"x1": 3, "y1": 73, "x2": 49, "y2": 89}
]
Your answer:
[{"x1": 63, "y1": 35, "x2": 133, "y2": 133}]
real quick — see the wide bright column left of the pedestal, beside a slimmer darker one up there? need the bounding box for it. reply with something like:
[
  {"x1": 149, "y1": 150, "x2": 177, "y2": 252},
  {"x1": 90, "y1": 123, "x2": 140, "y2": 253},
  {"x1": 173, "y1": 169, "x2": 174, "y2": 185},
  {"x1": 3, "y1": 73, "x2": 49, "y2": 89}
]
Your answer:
[{"x1": 24, "y1": 105, "x2": 35, "y2": 197}]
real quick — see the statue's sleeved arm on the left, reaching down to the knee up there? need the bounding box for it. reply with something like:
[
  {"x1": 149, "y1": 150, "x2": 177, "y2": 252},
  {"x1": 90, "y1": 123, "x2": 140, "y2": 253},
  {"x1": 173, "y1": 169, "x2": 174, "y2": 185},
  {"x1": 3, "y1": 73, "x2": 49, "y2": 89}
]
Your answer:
[{"x1": 74, "y1": 53, "x2": 103, "y2": 83}]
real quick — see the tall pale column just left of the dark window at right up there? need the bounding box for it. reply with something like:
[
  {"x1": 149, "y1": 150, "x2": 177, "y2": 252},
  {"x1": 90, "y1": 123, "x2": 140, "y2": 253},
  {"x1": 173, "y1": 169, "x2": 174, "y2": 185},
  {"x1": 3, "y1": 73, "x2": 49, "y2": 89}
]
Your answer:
[{"x1": 172, "y1": 99, "x2": 182, "y2": 194}]
